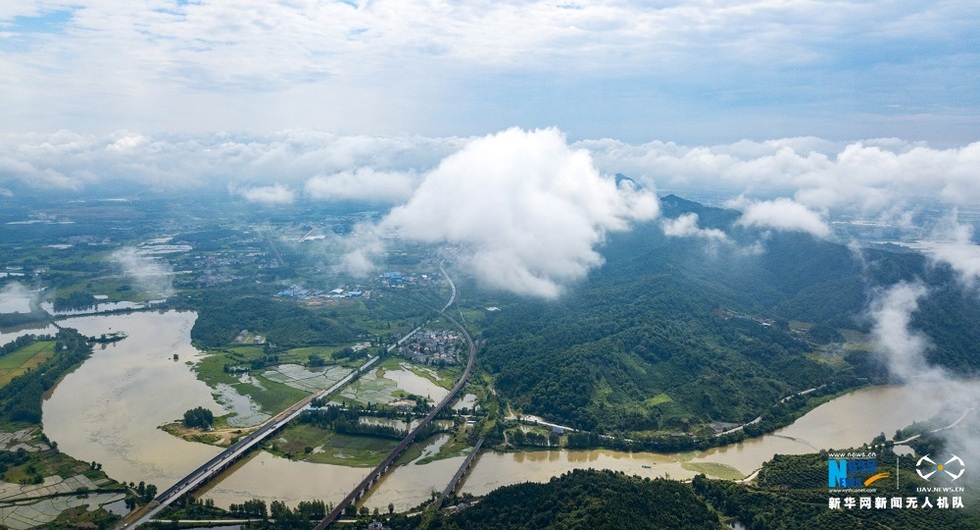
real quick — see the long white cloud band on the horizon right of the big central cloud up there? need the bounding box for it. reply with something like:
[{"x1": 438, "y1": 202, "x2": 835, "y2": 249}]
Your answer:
[{"x1": 578, "y1": 138, "x2": 980, "y2": 217}]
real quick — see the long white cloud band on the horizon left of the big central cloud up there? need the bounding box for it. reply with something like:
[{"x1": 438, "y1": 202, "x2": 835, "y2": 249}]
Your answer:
[{"x1": 0, "y1": 131, "x2": 456, "y2": 195}]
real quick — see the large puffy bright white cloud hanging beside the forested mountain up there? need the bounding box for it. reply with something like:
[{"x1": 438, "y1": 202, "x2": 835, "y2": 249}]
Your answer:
[{"x1": 362, "y1": 129, "x2": 658, "y2": 297}]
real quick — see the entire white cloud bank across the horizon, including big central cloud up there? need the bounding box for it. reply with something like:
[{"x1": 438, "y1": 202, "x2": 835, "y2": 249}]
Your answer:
[{"x1": 0, "y1": 129, "x2": 980, "y2": 296}]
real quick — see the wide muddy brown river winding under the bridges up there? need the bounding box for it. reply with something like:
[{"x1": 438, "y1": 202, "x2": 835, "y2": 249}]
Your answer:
[{"x1": 0, "y1": 311, "x2": 950, "y2": 511}]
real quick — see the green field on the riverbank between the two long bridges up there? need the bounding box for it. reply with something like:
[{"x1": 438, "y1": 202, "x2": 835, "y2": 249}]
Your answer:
[{"x1": 266, "y1": 418, "x2": 398, "y2": 467}]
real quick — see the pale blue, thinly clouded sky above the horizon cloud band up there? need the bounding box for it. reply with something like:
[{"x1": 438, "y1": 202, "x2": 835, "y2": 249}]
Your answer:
[{"x1": 0, "y1": 0, "x2": 980, "y2": 146}]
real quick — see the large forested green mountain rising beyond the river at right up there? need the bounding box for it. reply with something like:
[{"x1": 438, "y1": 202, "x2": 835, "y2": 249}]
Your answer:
[{"x1": 480, "y1": 196, "x2": 980, "y2": 431}]
